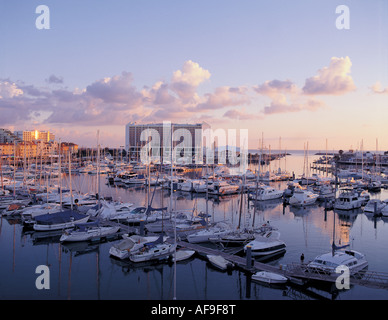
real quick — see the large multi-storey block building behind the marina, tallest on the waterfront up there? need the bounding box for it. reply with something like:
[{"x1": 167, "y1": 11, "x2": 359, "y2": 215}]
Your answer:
[{"x1": 125, "y1": 122, "x2": 210, "y2": 163}]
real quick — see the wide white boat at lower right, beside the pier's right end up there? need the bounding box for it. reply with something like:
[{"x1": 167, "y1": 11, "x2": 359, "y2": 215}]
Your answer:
[{"x1": 307, "y1": 250, "x2": 368, "y2": 275}]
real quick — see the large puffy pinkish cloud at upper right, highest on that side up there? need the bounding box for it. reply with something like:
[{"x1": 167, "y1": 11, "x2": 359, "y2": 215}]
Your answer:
[{"x1": 303, "y1": 57, "x2": 356, "y2": 95}]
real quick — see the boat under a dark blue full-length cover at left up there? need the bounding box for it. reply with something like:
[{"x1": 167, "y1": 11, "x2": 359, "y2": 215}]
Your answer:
[{"x1": 33, "y1": 210, "x2": 90, "y2": 231}]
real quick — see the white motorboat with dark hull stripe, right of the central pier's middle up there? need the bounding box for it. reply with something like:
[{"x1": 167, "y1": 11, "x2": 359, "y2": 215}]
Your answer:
[{"x1": 244, "y1": 231, "x2": 286, "y2": 257}]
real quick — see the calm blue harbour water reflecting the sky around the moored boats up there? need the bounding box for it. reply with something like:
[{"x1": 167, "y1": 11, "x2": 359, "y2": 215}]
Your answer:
[{"x1": 0, "y1": 151, "x2": 388, "y2": 300}]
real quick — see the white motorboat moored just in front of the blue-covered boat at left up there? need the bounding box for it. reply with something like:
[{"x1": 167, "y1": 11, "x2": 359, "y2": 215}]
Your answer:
[{"x1": 59, "y1": 221, "x2": 120, "y2": 242}]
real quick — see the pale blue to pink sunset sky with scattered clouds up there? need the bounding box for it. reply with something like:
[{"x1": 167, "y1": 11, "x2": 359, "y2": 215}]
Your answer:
[{"x1": 0, "y1": 0, "x2": 388, "y2": 151}]
